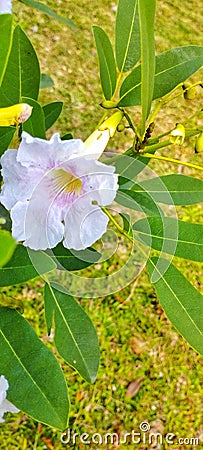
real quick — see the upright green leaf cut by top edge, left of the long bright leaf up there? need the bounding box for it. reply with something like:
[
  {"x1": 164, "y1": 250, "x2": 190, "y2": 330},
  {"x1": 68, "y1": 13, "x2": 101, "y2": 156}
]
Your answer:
[{"x1": 116, "y1": 0, "x2": 140, "y2": 73}]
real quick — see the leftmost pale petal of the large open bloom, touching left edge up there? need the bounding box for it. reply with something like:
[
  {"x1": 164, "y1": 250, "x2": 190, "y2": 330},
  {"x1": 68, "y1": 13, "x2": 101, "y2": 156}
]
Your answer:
[{"x1": 0, "y1": 150, "x2": 43, "y2": 209}]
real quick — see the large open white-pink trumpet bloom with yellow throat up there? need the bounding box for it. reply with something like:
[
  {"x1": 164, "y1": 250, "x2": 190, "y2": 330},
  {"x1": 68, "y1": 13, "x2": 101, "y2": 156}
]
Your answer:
[{"x1": 0, "y1": 130, "x2": 118, "y2": 250}]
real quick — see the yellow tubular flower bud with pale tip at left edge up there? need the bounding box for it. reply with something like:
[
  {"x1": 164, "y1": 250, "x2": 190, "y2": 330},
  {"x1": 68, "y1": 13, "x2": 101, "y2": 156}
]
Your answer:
[{"x1": 0, "y1": 103, "x2": 32, "y2": 127}]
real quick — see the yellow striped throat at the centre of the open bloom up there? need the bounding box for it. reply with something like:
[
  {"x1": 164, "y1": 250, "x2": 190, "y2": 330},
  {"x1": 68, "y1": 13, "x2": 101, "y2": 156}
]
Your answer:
[{"x1": 54, "y1": 169, "x2": 82, "y2": 195}]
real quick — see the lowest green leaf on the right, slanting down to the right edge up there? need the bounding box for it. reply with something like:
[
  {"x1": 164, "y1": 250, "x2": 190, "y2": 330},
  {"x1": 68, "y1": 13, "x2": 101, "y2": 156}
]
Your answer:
[{"x1": 147, "y1": 258, "x2": 203, "y2": 355}]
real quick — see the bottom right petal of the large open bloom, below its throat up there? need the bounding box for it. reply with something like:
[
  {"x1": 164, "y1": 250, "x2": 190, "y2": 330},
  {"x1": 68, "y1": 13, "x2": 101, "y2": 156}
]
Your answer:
[{"x1": 63, "y1": 194, "x2": 108, "y2": 250}]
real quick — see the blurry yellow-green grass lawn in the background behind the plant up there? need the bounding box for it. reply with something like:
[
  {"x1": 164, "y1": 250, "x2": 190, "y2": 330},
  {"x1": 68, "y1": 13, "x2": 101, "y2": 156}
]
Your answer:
[{"x1": 0, "y1": 0, "x2": 203, "y2": 450}]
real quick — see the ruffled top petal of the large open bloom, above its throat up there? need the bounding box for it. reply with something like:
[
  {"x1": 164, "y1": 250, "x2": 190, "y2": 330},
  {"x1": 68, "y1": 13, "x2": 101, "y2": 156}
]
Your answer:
[{"x1": 17, "y1": 131, "x2": 84, "y2": 171}]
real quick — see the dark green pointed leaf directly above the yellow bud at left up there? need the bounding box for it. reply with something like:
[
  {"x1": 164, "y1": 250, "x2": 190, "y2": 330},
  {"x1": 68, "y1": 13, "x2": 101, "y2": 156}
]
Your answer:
[{"x1": 0, "y1": 25, "x2": 40, "y2": 107}]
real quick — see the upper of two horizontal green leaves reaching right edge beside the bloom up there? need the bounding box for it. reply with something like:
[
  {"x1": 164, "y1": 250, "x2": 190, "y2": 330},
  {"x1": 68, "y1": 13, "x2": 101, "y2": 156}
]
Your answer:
[{"x1": 131, "y1": 174, "x2": 203, "y2": 205}]
